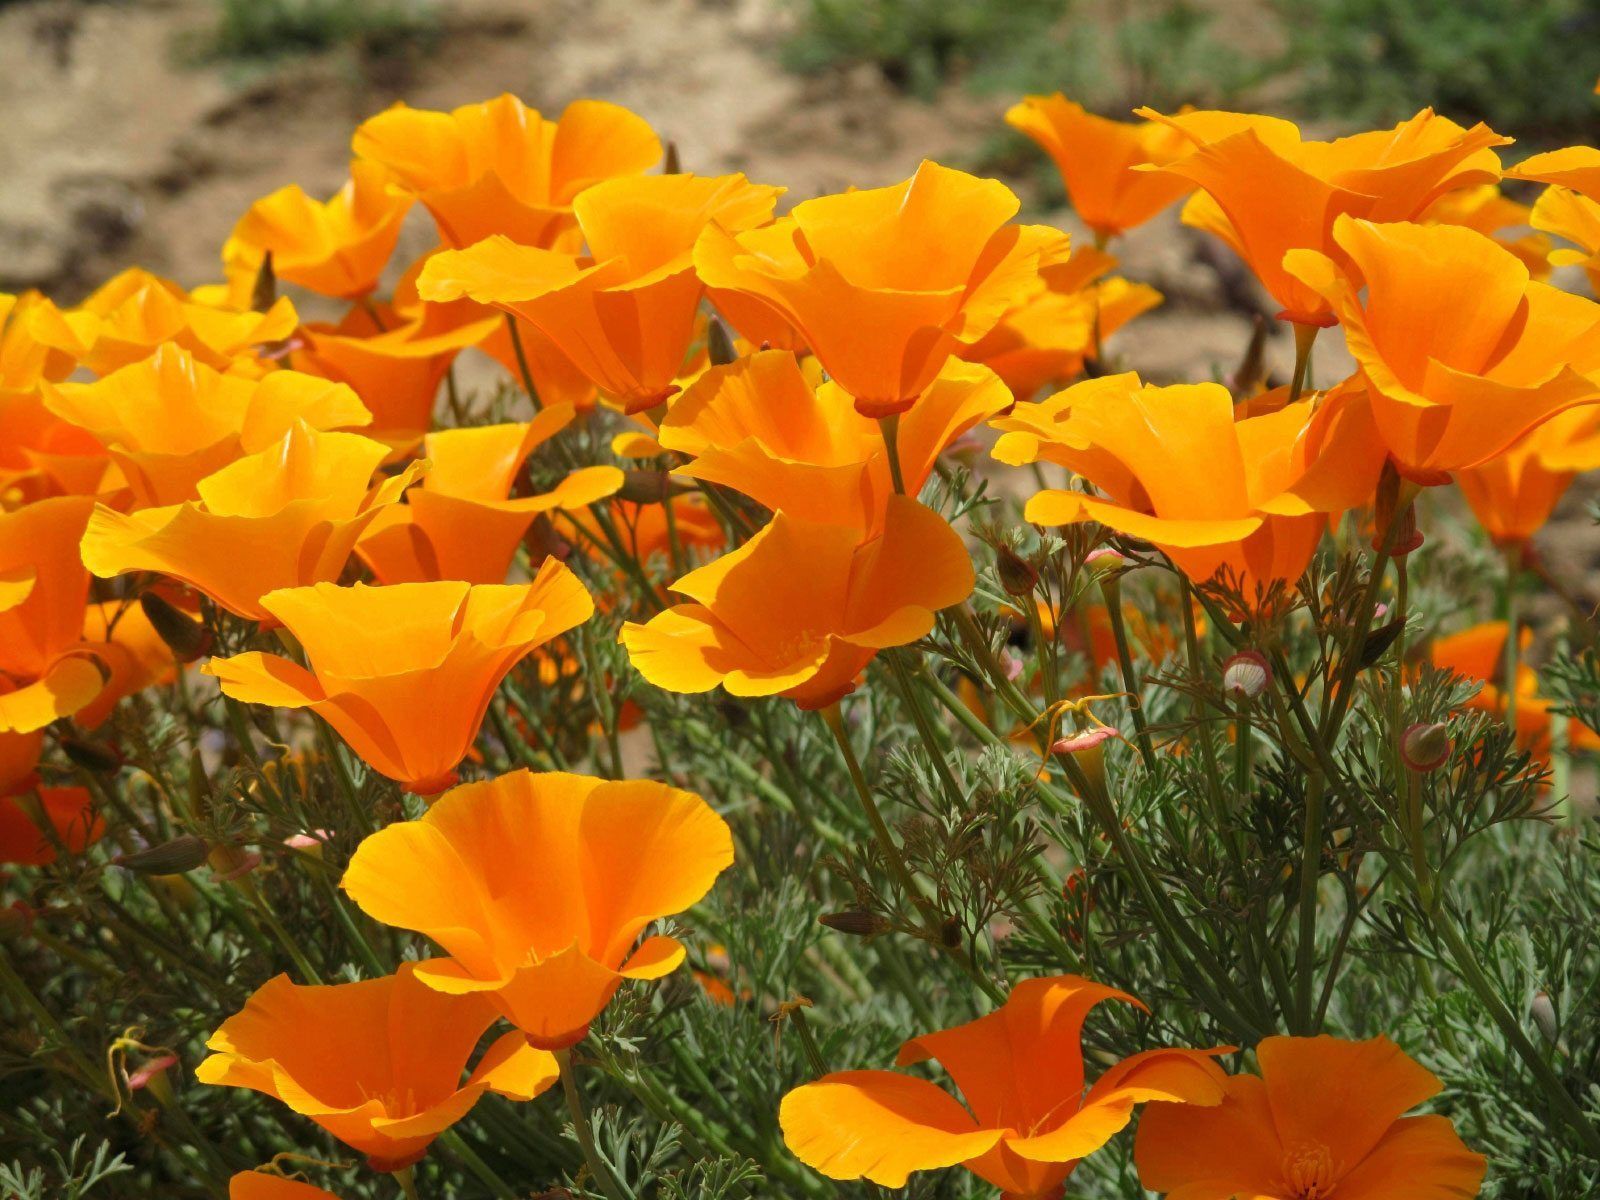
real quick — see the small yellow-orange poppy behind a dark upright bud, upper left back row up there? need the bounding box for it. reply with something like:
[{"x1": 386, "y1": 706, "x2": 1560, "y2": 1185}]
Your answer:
[{"x1": 222, "y1": 162, "x2": 413, "y2": 298}]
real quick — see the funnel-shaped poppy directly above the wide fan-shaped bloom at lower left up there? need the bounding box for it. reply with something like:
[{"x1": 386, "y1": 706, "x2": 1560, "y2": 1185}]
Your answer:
[{"x1": 203, "y1": 572, "x2": 594, "y2": 795}]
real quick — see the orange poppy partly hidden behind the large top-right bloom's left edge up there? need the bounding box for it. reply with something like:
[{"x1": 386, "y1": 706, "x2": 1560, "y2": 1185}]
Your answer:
[{"x1": 1005, "y1": 91, "x2": 1194, "y2": 240}]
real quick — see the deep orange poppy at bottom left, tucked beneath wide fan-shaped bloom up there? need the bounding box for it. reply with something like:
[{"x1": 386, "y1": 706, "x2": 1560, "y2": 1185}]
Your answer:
[{"x1": 195, "y1": 963, "x2": 560, "y2": 1171}]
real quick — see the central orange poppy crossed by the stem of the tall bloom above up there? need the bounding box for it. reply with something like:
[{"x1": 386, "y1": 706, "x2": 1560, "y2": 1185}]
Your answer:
[{"x1": 659, "y1": 350, "x2": 1011, "y2": 531}]
